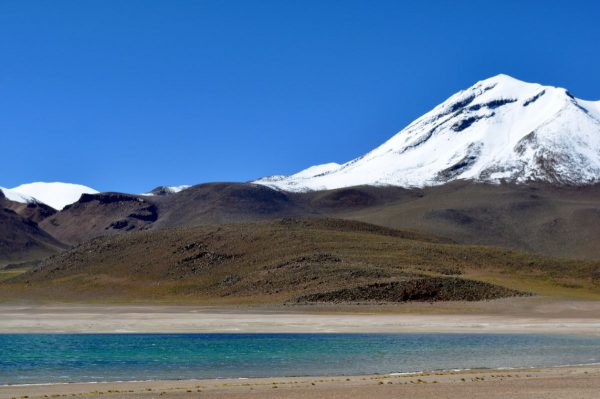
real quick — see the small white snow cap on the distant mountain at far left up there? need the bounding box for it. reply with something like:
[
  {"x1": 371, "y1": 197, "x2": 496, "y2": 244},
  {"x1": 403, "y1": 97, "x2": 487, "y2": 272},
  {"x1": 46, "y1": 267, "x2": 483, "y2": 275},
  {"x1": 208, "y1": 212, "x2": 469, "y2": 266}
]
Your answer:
[{"x1": 3, "y1": 182, "x2": 98, "y2": 210}]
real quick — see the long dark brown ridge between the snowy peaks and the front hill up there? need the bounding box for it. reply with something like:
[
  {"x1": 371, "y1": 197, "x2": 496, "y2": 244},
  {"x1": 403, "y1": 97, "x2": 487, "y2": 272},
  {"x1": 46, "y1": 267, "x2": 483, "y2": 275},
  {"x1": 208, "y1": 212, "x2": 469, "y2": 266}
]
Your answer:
[{"x1": 41, "y1": 182, "x2": 600, "y2": 259}]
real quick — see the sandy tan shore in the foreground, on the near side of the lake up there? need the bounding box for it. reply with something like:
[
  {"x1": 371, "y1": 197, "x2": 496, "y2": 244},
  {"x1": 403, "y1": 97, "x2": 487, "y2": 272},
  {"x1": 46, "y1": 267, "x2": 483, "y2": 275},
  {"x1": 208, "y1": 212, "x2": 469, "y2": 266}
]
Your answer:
[{"x1": 0, "y1": 366, "x2": 600, "y2": 399}]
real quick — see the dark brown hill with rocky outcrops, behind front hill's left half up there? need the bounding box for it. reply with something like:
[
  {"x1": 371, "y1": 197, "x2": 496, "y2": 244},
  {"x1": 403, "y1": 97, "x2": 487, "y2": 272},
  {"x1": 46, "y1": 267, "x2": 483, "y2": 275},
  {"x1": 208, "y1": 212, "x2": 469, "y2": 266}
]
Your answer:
[{"x1": 41, "y1": 183, "x2": 312, "y2": 244}]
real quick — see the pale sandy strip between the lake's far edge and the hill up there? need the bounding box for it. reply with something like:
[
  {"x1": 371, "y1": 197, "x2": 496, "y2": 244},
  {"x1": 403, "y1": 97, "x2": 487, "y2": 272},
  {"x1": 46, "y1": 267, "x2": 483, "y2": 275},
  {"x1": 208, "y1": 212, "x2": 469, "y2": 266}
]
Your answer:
[{"x1": 0, "y1": 299, "x2": 600, "y2": 335}]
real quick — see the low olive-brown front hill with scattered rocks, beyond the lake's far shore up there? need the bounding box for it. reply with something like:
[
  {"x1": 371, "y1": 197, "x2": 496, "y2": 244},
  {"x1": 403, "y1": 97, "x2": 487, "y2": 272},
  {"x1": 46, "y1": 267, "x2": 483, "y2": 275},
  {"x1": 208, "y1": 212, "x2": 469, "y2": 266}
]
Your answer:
[{"x1": 0, "y1": 218, "x2": 600, "y2": 304}]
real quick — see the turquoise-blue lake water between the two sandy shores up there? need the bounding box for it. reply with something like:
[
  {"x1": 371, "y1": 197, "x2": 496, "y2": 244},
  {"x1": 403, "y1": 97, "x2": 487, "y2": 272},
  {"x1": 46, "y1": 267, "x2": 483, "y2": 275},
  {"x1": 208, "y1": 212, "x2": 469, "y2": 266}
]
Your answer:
[{"x1": 0, "y1": 334, "x2": 600, "y2": 384}]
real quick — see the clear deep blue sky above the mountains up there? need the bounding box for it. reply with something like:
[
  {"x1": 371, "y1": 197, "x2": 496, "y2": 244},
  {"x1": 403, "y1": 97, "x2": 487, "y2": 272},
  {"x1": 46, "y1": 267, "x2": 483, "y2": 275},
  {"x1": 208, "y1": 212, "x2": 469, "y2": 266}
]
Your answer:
[{"x1": 0, "y1": 0, "x2": 600, "y2": 192}]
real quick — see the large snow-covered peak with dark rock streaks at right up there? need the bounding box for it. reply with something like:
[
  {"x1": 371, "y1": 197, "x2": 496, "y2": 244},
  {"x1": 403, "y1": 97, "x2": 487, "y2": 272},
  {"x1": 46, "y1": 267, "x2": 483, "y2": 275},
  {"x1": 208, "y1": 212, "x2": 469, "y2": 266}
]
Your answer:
[{"x1": 254, "y1": 75, "x2": 600, "y2": 191}]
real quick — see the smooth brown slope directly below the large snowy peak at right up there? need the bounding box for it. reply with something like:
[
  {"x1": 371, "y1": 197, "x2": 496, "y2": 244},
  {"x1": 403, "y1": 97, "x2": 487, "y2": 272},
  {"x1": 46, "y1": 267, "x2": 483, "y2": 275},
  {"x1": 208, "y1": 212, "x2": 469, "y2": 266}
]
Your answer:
[{"x1": 322, "y1": 182, "x2": 600, "y2": 259}]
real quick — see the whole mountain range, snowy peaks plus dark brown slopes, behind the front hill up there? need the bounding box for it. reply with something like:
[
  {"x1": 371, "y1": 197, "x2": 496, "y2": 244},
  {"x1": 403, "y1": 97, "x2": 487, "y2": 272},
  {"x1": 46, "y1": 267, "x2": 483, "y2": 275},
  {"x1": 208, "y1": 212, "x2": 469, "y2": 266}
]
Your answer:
[{"x1": 0, "y1": 75, "x2": 600, "y2": 268}]
